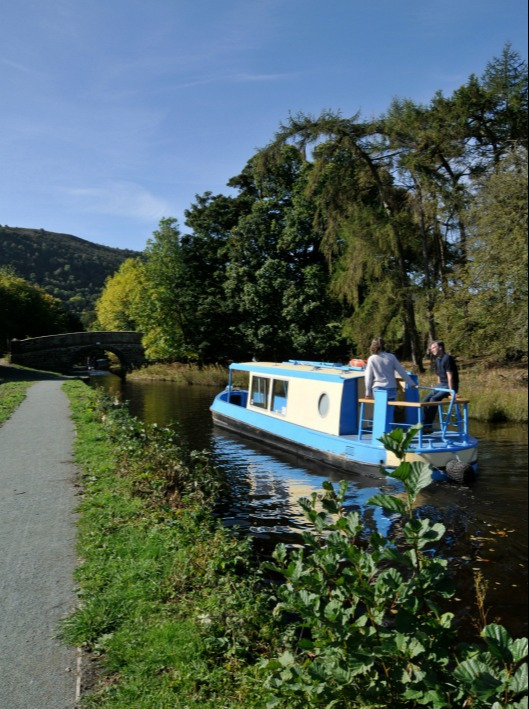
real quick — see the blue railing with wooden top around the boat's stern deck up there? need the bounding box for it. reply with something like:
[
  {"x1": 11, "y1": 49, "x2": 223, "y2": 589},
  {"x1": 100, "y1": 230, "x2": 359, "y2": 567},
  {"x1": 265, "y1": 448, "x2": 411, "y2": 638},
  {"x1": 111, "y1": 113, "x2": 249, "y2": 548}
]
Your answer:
[{"x1": 358, "y1": 386, "x2": 469, "y2": 446}]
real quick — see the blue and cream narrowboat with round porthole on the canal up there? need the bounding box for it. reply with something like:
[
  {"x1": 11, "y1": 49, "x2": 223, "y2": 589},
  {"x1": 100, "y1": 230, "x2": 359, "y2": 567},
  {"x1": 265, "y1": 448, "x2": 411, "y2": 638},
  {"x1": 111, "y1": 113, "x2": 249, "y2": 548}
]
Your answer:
[{"x1": 211, "y1": 360, "x2": 477, "y2": 482}]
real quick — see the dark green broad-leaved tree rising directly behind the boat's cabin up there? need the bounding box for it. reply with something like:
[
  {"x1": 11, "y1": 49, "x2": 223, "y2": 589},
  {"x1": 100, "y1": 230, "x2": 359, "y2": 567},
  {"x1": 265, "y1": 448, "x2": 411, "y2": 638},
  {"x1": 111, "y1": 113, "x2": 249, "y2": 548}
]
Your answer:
[{"x1": 225, "y1": 146, "x2": 346, "y2": 359}]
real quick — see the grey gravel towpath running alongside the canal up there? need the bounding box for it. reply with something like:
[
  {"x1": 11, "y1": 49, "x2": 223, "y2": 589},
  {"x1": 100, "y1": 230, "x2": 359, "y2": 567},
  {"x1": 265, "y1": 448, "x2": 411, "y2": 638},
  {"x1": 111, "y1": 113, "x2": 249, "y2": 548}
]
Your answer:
[{"x1": 0, "y1": 367, "x2": 78, "y2": 709}]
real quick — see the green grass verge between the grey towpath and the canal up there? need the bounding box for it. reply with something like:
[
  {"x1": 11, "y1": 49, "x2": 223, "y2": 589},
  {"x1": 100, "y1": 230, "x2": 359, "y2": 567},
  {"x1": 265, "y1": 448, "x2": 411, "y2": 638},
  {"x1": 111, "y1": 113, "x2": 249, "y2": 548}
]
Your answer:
[{"x1": 62, "y1": 381, "x2": 270, "y2": 709}]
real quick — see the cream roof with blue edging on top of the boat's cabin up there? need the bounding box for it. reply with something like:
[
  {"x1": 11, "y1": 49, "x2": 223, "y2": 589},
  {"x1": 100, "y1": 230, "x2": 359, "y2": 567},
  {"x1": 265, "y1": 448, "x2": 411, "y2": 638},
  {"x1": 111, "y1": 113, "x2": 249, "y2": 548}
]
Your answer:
[{"x1": 230, "y1": 359, "x2": 365, "y2": 382}]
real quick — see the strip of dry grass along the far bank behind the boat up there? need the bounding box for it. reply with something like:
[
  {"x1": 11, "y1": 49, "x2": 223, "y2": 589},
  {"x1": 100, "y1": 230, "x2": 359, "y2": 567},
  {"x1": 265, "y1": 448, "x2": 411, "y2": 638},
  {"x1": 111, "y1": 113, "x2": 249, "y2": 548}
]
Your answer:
[{"x1": 129, "y1": 362, "x2": 528, "y2": 423}]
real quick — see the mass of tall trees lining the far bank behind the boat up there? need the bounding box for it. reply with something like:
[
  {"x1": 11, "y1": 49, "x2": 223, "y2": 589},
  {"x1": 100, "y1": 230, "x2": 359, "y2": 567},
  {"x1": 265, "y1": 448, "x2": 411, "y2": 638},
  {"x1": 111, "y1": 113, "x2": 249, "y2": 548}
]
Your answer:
[{"x1": 94, "y1": 45, "x2": 527, "y2": 371}]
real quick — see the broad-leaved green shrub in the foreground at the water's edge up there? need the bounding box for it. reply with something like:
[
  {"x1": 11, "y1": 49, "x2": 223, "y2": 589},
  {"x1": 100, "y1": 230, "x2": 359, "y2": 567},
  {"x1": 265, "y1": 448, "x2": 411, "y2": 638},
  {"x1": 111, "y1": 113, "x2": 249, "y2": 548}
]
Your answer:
[{"x1": 262, "y1": 427, "x2": 527, "y2": 709}]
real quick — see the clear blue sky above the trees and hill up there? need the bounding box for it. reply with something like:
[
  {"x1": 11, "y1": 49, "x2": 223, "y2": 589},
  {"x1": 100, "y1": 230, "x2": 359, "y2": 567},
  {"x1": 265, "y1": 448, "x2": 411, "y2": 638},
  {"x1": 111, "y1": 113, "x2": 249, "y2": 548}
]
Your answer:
[{"x1": 0, "y1": 0, "x2": 527, "y2": 250}]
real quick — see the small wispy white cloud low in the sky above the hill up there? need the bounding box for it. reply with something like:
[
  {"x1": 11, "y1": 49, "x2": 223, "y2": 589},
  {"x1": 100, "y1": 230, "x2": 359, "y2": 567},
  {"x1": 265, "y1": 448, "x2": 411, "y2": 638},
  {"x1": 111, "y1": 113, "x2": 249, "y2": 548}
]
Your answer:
[{"x1": 68, "y1": 181, "x2": 171, "y2": 221}]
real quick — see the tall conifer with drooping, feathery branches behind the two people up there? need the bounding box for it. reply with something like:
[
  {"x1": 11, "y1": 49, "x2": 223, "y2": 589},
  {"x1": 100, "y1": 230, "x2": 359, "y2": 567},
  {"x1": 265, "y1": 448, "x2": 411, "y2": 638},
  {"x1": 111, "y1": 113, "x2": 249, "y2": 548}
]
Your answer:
[{"x1": 266, "y1": 112, "x2": 422, "y2": 370}]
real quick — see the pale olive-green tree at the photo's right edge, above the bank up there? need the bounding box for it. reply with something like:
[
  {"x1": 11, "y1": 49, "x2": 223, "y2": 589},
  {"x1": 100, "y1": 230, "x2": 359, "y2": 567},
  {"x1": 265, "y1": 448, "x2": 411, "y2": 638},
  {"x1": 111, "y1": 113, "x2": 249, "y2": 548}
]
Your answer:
[{"x1": 439, "y1": 148, "x2": 528, "y2": 360}]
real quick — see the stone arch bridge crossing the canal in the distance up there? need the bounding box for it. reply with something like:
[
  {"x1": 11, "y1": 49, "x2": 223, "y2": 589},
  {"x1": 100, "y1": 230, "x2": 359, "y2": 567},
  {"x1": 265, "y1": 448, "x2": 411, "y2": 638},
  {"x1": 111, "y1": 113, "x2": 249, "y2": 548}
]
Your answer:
[{"x1": 11, "y1": 332, "x2": 145, "y2": 376}]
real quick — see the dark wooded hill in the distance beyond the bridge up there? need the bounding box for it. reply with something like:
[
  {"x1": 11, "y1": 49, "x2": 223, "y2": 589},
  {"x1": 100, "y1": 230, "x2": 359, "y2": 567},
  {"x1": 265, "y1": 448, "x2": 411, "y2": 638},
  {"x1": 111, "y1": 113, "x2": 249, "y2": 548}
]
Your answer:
[{"x1": 0, "y1": 226, "x2": 140, "y2": 319}]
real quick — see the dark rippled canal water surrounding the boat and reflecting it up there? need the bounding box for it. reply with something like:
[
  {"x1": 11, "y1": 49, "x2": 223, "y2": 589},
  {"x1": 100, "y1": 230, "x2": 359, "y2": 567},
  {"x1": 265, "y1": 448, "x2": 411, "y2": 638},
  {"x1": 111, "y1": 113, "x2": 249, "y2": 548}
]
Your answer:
[{"x1": 92, "y1": 375, "x2": 528, "y2": 637}]
